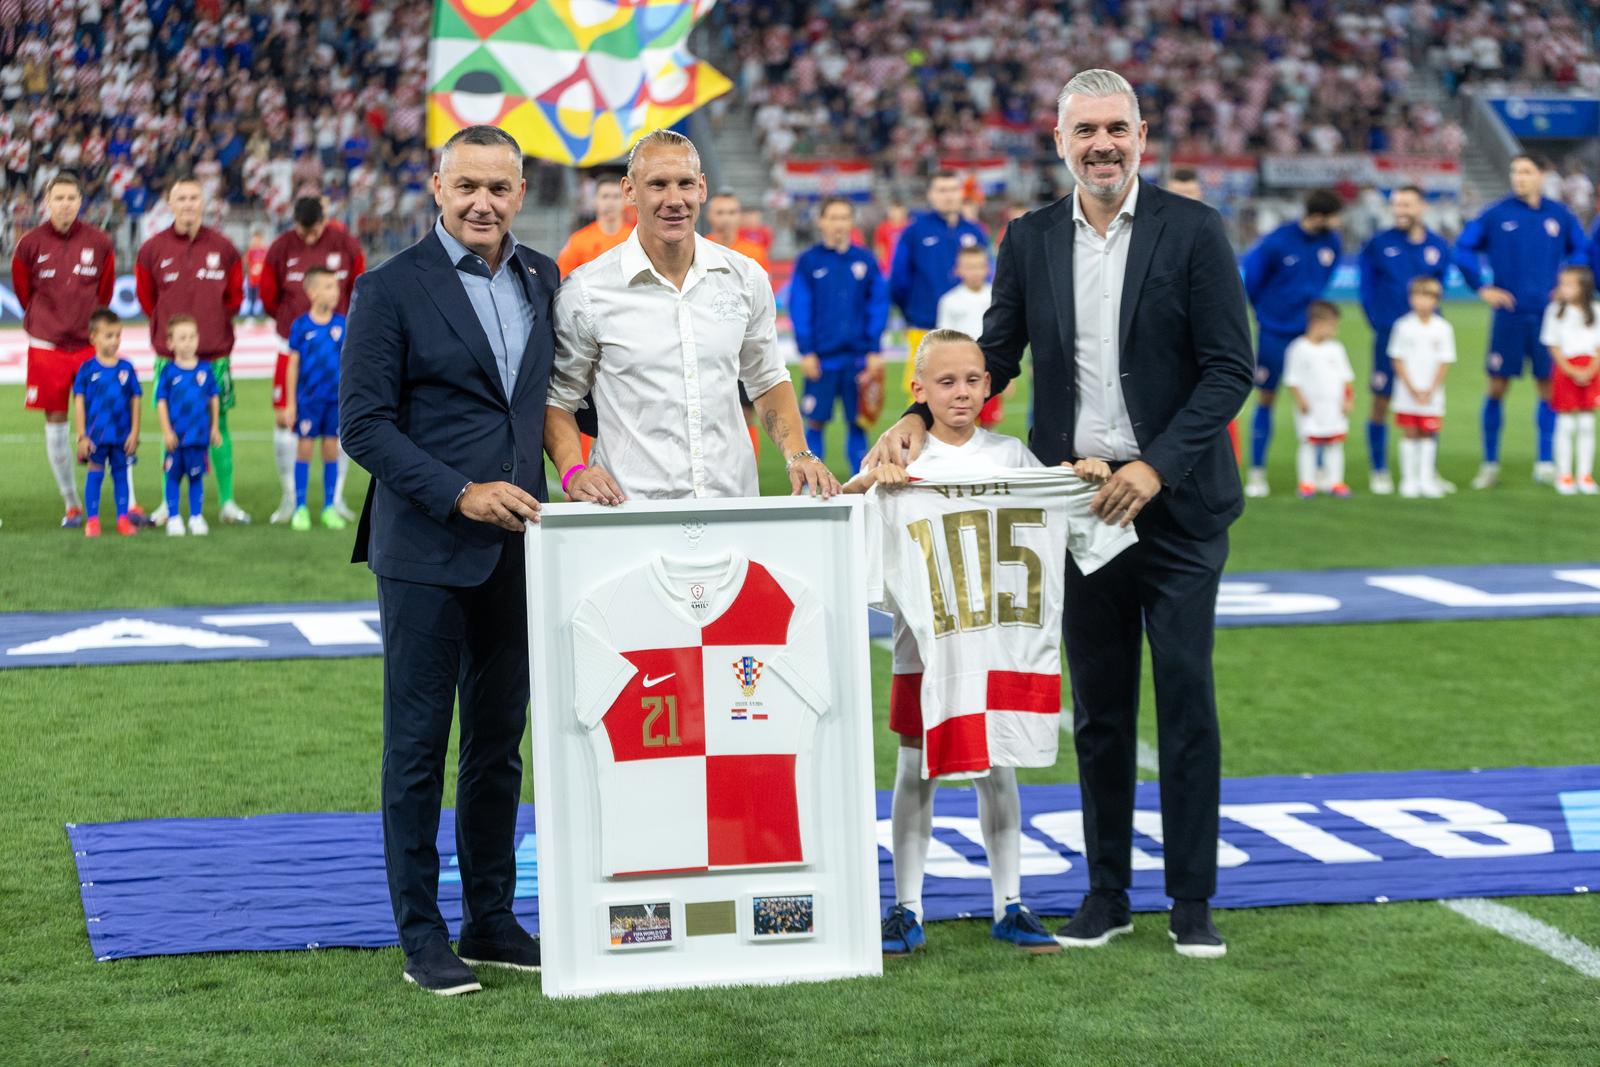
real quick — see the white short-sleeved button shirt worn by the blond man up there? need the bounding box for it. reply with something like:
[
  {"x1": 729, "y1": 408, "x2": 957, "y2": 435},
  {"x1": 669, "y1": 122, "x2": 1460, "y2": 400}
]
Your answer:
[{"x1": 549, "y1": 230, "x2": 789, "y2": 498}]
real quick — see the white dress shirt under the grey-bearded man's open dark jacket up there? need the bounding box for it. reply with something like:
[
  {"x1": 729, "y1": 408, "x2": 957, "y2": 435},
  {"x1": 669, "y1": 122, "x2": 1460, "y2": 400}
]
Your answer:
[{"x1": 1072, "y1": 178, "x2": 1139, "y2": 461}]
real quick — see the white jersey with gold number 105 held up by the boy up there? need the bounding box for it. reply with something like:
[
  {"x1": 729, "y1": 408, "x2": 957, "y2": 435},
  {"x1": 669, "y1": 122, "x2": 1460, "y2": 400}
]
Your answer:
[{"x1": 867, "y1": 430, "x2": 1138, "y2": 777}]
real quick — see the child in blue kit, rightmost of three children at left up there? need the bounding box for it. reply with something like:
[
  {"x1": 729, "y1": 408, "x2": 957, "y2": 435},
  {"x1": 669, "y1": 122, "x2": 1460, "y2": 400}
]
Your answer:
[{"x1": 286, "y1": 267, "x2": 346, "y2": 533}]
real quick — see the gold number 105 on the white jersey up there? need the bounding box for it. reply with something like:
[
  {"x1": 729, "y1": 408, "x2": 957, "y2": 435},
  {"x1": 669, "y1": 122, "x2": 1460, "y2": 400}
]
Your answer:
[{"x1": 906, "y1": 507, "x2": 1045, "y2": 637}]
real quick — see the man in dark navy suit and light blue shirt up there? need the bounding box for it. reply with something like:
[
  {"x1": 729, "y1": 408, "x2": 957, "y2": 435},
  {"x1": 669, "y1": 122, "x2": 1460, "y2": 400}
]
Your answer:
[{"x1": 339, "y1": 126, "x2": 560, "y2": 995}]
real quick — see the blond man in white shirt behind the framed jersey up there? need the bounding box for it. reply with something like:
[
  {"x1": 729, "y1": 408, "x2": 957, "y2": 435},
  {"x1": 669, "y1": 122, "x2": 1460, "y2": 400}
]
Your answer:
[{"x1": 544, "y1": 130, "x2": 838, "y2": 504}]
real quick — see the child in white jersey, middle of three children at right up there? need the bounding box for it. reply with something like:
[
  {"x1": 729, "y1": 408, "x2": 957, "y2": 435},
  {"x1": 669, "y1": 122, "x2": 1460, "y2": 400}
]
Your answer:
[{"x1": 1389, "y1": 277, "x2": 1456, "y2": 499}]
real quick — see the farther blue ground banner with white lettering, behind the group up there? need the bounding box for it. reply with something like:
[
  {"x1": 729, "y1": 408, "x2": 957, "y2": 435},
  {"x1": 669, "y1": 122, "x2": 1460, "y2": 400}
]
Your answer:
[{"x1": 9, "y1": 563, "x2": 1600, "y2": 669}]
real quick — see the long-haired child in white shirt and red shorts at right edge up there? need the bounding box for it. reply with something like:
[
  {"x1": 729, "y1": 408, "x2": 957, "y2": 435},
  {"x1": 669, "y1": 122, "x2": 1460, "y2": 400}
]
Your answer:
[{"x1": 1539, "y1": 267, "x2": 1600, "y2": 496}]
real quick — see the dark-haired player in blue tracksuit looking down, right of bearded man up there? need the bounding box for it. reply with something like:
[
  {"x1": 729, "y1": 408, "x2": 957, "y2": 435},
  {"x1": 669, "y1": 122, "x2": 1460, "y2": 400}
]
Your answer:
[{"x1": 1245, "y1": 189, "x2": 1342, "y2": 496}]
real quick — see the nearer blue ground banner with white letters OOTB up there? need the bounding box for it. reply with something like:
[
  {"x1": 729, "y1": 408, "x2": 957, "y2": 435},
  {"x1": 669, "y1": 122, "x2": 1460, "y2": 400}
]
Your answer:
[{"x1": 67, "y1": 766, "x2": 1600, "y2": 960}]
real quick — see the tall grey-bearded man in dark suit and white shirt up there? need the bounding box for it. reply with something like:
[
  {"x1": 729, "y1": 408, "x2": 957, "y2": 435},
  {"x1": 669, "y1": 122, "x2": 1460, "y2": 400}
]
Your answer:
[{"x1": 869, "y1": 70, "x2": 1254, "y2": 957}]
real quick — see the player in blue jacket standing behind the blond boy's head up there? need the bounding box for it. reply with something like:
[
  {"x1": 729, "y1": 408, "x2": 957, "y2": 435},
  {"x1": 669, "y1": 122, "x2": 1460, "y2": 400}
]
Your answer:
[{"x1": 890, "y1": 171, "x2": 989, "y2": 395}]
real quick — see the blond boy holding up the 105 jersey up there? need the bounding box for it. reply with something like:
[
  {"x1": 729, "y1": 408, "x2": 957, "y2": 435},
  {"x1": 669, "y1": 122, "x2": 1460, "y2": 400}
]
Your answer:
[{"x1": 845, "y1": 330, "x2": 1110, "y2": 955}]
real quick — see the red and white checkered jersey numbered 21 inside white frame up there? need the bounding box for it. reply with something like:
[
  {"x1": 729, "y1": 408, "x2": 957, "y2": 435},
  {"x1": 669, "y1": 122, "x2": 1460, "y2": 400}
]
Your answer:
[{"x1": 573, "y1": 555, "x2": 830, "y2": 877}]
